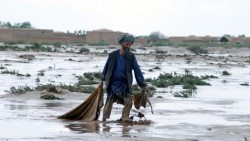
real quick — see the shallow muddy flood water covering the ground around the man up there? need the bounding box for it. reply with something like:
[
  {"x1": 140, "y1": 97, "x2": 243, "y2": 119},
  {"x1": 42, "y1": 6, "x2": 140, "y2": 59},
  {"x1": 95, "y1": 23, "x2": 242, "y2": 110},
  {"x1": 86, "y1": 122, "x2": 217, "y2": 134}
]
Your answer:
[{"x1": 0, "y1": 47, "x2": 250, "y2": 141}]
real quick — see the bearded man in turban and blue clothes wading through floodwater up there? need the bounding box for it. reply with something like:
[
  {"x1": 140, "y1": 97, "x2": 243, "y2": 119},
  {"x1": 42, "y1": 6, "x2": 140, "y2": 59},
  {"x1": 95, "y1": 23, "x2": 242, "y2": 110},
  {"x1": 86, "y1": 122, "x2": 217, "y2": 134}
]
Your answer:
[{"x1": 101, "y1": 34, "x2": 147, "y2": 122}]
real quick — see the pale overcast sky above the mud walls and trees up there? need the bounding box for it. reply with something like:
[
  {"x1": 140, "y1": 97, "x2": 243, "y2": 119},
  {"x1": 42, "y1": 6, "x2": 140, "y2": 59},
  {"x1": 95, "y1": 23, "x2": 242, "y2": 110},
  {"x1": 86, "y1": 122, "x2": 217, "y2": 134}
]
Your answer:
[{"x1": 0, "y1": 0, "x2": 250, "y2": 36}]
